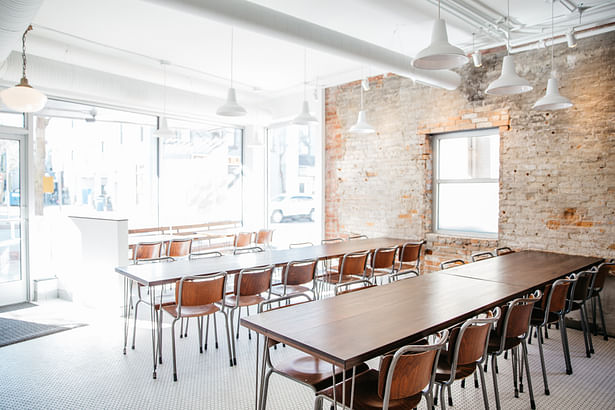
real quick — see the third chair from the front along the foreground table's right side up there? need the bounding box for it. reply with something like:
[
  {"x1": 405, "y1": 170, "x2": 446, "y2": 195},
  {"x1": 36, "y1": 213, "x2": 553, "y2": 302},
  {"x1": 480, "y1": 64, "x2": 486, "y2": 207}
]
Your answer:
[{"x1": 485, "y1": 290, "x2": 542, "y2": 410}]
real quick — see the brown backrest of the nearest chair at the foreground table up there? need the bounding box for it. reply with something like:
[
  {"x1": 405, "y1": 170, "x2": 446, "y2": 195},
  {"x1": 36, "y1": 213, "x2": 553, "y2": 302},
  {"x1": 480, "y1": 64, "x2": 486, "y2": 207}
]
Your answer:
[{"x1": 378, "y1": 350, "x2": 438, "y2": 400}]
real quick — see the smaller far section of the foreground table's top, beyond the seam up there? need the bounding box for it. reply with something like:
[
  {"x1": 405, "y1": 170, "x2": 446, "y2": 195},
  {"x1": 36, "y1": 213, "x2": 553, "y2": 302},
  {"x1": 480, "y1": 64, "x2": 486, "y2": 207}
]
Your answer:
[{"x1": 442, "y1": 251, "x2": 603, "y2": 289}]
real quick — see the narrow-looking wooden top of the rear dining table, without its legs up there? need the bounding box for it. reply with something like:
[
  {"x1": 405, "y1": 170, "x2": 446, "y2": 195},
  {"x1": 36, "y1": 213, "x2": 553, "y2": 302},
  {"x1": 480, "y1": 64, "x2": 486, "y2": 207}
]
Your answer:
[{"x1": 115, "y1": 238, "x2": 408, "y2": 286}]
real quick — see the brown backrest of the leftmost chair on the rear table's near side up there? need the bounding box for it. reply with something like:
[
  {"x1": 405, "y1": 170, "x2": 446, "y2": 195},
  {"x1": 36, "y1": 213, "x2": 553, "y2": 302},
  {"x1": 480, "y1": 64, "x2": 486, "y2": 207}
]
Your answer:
[{"x1": 175, "y1": 274, "x2": 226, "y2": 306}]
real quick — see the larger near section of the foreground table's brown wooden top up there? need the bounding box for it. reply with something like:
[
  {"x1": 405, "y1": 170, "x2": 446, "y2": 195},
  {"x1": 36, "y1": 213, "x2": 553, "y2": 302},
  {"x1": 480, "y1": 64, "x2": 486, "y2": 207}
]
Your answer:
[{"x1": 241, "y1": 273, "x2": 525, "y2": 369}]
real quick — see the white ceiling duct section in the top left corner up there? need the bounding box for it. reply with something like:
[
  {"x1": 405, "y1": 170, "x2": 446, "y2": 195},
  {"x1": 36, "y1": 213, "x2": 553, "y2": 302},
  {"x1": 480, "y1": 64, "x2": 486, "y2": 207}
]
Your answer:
[{"x1": 0, "y1": 0, "x2": 43, "y2": 62}]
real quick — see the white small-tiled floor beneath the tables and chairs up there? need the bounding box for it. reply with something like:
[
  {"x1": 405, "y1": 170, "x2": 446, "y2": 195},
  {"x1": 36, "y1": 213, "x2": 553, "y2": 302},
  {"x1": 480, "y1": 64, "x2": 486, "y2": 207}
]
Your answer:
[{"x1": 0, "y1": 301, "x2": 615, "y2": 410}]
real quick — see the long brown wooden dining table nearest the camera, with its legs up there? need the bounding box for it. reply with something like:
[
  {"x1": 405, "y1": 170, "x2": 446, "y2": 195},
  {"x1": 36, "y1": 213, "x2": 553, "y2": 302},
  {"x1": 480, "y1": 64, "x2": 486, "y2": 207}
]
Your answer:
[{"x1": 241, "y1": 251, "x2": 602, "y2": 408}]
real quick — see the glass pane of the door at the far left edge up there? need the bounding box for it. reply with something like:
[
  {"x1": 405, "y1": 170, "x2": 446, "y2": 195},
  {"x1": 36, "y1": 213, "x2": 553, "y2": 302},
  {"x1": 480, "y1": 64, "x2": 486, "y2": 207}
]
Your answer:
[{"x1": 0, "y1": 132, "x2": 28, "y2": 306}]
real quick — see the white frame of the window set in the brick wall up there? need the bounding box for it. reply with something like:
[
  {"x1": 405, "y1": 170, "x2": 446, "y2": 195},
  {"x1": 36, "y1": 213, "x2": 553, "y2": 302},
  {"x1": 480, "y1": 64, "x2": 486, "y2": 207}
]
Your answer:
[{"x1": 431, "y1": 128, "x2": 501, "y2": 239}]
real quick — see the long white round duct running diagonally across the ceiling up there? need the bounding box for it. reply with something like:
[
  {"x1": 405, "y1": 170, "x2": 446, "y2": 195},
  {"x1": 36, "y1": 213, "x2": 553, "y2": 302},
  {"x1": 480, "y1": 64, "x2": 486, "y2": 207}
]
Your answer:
[{"x1": 147, "y1": 0, "x2": 461, "y2": 90}]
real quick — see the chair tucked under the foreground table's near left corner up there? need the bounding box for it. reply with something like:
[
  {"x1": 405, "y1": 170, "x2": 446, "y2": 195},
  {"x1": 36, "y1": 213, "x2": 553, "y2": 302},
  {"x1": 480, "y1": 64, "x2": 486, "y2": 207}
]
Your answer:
[{"x1": 256, "y1": 293, "x2": 369, "y2": 410}]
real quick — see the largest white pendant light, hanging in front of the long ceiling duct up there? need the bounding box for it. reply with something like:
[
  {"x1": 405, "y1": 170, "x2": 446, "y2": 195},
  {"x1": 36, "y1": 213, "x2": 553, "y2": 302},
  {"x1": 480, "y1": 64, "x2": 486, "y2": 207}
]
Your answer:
[{"x1": 412, "y1": 0, "x2": 468, "y2": 70}]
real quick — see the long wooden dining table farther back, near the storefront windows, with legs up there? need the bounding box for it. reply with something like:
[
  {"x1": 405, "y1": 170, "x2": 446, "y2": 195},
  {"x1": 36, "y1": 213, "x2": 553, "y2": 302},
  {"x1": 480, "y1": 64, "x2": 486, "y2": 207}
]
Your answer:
[{"x1": 115, "y1": 238, "x2": 412, "y2": 379}]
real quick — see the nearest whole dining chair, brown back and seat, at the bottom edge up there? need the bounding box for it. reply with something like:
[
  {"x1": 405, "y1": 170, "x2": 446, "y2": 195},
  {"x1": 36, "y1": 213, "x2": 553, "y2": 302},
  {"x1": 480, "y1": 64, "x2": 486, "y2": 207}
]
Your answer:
[{"x1": 315, "y1": 330, "x2": 448, "y2": 410}]
